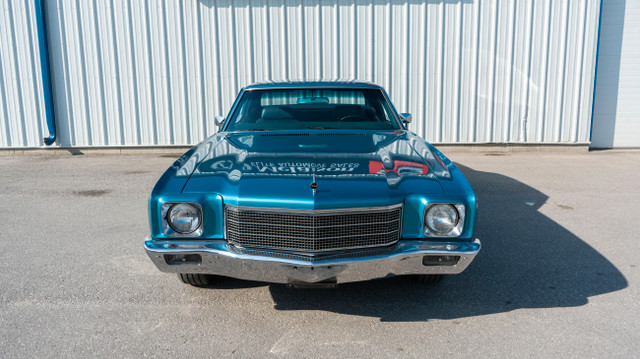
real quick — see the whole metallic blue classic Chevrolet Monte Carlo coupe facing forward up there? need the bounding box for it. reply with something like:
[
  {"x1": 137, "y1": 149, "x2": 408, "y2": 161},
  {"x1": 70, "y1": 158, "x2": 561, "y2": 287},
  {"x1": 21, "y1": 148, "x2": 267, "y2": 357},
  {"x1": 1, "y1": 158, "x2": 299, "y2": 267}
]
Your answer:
[{"x1": 145, "y1": 82, "x2": 480, "y2": 286}]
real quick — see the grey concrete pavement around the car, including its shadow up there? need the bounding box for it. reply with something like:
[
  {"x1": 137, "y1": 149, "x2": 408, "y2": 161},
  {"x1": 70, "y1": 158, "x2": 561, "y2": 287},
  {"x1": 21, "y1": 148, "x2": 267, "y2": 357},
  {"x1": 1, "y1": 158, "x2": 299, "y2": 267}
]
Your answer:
[{"x1": 0, "y1": 151, "x2": 640, "y2": 358}]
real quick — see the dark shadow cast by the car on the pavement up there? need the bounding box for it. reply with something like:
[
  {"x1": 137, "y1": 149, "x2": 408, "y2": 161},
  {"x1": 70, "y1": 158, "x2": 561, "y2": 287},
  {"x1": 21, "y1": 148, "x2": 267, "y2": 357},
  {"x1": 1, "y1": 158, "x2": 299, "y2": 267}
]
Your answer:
[{"x1": 262, "y1": 165, "x2": 628, "y2": 321}]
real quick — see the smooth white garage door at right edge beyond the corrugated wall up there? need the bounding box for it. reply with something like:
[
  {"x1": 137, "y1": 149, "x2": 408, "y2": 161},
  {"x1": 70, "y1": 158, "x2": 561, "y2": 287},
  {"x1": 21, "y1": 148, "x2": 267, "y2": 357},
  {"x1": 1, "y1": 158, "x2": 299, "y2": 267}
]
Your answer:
[{"x1": 591, "y1": 0, "x2": 640, "y2": 148}]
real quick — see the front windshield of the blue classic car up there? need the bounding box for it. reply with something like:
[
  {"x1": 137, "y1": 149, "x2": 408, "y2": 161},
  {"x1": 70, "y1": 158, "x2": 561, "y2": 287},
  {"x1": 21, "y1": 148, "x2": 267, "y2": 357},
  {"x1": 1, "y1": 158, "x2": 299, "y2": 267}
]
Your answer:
[{"x1": 222, "y1": 89, "x2": 400, "y2": 131}]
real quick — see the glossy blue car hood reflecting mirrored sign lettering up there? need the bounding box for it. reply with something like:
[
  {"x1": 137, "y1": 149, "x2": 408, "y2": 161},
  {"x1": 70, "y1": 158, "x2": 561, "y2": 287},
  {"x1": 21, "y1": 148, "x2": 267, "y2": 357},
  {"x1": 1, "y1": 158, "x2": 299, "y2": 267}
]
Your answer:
[{"x1": 178, "y1": 131, "x2": 449, "y2": 209}]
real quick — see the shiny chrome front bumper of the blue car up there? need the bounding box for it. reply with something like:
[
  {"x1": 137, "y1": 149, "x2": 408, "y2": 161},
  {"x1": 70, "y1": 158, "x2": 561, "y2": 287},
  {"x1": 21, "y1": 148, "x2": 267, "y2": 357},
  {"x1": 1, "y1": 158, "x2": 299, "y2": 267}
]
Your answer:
[{"x1": 145, "y1": 238, "x2": 480, "y2": 283}]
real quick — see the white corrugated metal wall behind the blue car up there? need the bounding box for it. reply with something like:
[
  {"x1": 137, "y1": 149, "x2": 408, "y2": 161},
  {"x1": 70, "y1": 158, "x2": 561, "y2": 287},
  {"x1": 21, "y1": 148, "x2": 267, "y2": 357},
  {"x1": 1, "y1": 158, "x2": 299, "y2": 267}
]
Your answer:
[{"x1": 0, "y1": 0, "x2": 600, "y2": 147}]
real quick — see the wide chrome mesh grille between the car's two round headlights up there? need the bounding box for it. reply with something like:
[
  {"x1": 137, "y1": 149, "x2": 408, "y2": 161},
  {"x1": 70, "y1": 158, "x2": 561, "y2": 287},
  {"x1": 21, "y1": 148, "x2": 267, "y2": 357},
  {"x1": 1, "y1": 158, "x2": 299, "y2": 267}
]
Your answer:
[{"x1": 225, "y1": 205, "x2": 402, "y2": 252}]
